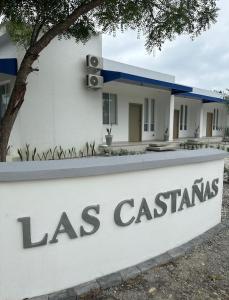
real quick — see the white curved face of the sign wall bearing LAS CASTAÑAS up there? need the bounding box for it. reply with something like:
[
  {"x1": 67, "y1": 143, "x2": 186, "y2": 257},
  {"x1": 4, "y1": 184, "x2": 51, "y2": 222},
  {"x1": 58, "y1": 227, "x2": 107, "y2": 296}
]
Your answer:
[{"x1": 0, "y1": 160, "x2": 224, "y2": 300}]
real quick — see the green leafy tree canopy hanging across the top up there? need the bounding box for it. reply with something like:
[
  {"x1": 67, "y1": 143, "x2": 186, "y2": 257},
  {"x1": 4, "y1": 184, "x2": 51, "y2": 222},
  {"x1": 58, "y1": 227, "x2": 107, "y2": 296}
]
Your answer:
[{"x1": 0, "y1": 0, "x2": 218, "y2": 50}]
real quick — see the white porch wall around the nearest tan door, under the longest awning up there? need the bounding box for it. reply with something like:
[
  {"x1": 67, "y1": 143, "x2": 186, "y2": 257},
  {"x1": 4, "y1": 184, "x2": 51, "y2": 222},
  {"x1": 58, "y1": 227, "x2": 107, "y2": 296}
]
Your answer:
[{"x1": 103, "y1": 82, "x2": 170, "y2": 142}]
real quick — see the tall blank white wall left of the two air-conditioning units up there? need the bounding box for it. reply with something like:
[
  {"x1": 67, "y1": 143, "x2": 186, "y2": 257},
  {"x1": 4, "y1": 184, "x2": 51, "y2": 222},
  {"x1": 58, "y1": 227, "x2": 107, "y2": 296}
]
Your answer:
[{"x1": 4, "y1": 36, "x2": 102, "y2": 155}]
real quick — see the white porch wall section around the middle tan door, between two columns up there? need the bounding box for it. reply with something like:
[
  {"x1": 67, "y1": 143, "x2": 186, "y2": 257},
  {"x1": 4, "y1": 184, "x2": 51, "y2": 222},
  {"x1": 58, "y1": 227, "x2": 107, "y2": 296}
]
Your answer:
[{"x1": 174, "y1": 97, "x2": 202, "y2": 138}]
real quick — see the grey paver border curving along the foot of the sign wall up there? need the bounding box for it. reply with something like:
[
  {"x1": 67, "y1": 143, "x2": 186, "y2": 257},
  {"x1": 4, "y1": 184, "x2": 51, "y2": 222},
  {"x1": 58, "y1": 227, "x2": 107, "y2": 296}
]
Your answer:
[{"x1": 28, "y1": 223, "x2": 225, "y2": 300}]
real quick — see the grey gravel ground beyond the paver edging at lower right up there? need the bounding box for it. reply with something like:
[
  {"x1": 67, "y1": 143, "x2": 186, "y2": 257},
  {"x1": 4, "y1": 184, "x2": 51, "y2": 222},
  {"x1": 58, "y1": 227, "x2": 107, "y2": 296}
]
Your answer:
[{"x1": 81, "y1": 184, "x2": 229, "y2": 300}]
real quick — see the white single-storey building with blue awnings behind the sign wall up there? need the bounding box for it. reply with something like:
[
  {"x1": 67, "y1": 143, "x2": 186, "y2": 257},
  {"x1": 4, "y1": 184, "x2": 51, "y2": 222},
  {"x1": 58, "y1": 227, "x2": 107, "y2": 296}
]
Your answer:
[{"x1": 0, "y1": 32, "x2": 227, "y2": 155}]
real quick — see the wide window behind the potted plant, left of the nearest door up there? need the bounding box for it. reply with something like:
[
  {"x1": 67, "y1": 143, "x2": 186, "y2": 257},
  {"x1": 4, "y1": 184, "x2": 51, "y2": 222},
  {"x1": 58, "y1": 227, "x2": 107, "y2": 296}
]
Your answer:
[{"x1": 103, "y1": 93, "x2": 117, "y2": 125}]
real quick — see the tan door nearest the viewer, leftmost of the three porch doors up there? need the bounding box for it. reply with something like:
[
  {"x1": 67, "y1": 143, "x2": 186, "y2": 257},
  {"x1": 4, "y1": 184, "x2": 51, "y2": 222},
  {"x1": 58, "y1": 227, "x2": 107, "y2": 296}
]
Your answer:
[{"x1": 129, "y1": 103, "x2": 142, "y2": 142}]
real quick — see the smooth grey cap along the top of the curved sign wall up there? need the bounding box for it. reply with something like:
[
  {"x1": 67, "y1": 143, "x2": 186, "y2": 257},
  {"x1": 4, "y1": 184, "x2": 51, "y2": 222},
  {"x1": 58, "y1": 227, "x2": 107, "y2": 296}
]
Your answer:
[{"x1": 0, "y1": 149, "x2": 228, "y2": 182}]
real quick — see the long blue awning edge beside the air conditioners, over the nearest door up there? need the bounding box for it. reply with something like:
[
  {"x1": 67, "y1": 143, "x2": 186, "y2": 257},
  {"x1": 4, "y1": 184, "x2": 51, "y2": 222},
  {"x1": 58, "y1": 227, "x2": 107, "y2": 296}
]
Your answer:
[{"x1": 101, "y1": 70, "x2": 193, "y2": 95}]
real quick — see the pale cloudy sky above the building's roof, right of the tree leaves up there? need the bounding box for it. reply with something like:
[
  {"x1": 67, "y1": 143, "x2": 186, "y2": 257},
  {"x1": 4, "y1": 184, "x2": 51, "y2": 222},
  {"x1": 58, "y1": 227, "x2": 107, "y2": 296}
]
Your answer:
[{"x1": 103, "y1": 0, "x2": 229, "y2": 90}]
